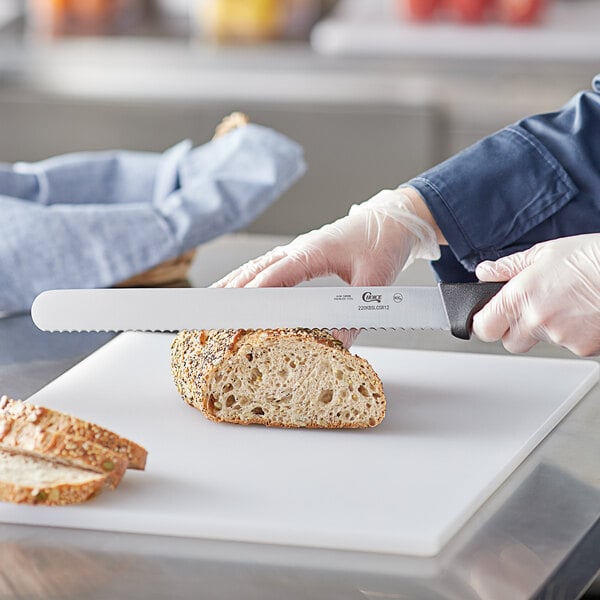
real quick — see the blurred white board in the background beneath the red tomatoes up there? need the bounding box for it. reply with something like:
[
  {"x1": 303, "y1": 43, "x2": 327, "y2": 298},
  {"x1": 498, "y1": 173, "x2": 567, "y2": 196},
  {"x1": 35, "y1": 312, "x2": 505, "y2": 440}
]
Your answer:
[{"x1": 311, "y1": 0, "x2": 600, "y2": 62}]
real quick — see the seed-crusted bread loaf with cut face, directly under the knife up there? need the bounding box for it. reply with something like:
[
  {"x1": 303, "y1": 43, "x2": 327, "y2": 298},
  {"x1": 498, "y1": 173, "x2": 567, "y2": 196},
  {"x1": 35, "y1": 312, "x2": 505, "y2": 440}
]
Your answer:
[{"x1": 171, "y1": 329, "x2": 386, "y2": 429}]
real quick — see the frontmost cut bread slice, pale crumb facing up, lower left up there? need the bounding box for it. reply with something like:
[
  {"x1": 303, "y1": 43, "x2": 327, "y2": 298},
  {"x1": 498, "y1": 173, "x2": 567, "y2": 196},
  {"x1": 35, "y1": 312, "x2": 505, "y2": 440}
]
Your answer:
[{"x1": 0, "y1": 449, "x2": 106, "y2": 505}]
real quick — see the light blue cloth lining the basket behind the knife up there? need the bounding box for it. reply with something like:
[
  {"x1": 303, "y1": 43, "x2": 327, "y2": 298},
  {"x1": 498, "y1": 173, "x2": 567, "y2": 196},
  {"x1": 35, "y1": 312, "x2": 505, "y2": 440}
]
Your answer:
[{"x1": 0, "y1": 125, "x2": 305, "y2": 312}]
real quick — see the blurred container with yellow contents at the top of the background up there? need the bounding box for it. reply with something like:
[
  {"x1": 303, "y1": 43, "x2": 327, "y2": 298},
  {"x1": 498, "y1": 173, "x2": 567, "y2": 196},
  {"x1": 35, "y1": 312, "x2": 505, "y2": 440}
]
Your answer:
[{"x1": 192, "y1": 0, "x2": 333, "y2": 43}]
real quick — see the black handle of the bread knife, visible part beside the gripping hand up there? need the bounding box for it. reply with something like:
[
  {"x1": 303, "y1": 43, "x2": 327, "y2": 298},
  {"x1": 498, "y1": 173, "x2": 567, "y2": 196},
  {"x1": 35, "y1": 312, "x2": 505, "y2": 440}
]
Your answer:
[{"x1": 438, "y1": 281, "x2": 506, "y2": 340}]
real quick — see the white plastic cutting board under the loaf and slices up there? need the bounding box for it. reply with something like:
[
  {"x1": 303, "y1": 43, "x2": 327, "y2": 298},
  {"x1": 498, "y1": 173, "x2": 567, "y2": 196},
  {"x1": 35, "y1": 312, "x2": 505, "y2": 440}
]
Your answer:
[{"x1": 0, "y1": 333, "x2": 598, "y2": 556}]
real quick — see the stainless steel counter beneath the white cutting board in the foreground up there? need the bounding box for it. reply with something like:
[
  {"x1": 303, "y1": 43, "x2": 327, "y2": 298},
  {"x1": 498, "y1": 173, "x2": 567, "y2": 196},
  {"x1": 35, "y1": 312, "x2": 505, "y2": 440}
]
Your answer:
[{"x1": 0, "y1": 235, "x2": 600, "y2": 600}]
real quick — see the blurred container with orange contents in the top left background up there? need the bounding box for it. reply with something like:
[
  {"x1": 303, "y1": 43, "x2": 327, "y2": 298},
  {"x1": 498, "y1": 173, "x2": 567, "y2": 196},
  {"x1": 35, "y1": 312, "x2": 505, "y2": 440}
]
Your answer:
[{"x1": 27, "y1": 0, "x2": 147, "y2": 36}]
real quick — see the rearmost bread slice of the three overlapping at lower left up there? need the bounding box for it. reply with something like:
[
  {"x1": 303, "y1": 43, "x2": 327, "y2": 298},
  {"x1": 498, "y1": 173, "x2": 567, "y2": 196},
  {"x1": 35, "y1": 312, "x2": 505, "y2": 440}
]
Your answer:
[{"x1": 0, "y1": 396, "x2": 148, "y2": 470}]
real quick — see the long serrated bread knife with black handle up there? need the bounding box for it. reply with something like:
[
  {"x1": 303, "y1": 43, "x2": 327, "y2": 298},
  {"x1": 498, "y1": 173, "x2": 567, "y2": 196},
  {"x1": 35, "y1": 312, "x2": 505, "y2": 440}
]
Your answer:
[{"x1": 31, "y1": 282, "x2": 503, "y2": 339}]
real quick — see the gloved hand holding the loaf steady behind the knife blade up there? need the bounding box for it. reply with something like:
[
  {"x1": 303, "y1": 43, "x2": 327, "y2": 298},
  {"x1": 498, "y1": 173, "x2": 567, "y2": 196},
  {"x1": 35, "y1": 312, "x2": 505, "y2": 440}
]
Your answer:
[{"x1": 214, "y1": 188, "x2": 440, "y2": 346}]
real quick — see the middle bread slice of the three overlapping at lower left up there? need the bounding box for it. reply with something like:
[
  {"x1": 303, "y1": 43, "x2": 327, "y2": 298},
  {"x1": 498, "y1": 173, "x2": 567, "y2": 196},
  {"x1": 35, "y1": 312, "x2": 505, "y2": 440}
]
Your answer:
[{"x1": 0, "y1": 412, "x2": 127, "y2": 488}]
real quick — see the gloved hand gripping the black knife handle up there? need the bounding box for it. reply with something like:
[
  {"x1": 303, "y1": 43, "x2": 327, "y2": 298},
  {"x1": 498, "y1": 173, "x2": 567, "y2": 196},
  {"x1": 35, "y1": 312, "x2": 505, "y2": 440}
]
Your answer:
[{"x1": 473, "y1": 233, "x2": 600, "y2": 356}]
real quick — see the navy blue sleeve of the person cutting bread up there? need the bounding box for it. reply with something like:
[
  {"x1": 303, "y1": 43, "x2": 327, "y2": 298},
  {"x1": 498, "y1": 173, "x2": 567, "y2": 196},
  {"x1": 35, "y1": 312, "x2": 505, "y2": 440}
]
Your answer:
[{"x1": 408, "y1": 76, "x2": 600, "y2": 281}]
